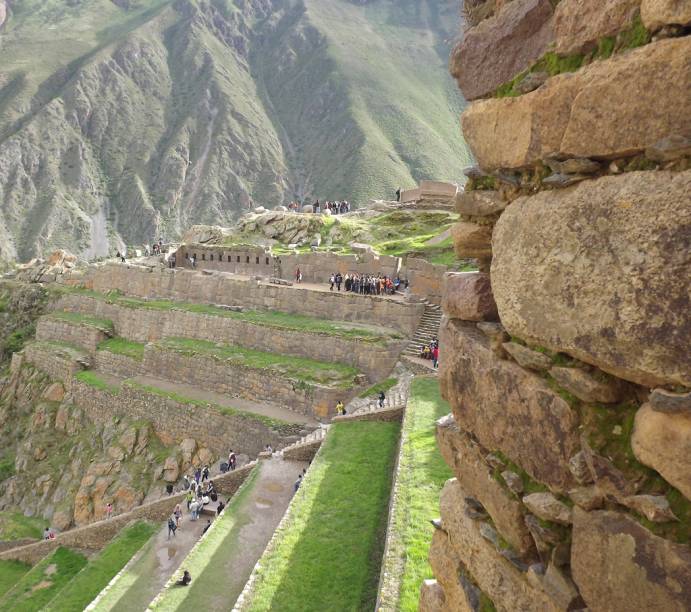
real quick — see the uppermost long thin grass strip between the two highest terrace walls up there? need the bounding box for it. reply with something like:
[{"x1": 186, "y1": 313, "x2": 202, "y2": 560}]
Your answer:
[{"x1": 64, "y1": 287, "x2": 403, "y2": 342}]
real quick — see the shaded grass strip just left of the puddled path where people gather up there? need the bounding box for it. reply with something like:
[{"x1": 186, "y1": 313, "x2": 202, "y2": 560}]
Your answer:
[{"x1": 45, "y1": 521, "x2": 159, "y2": 612}]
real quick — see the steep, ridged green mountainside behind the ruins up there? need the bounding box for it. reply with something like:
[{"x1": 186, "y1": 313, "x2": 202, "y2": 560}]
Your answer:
[{"x1": 0, "y1": 0, "x2": 469, "y2": 260}]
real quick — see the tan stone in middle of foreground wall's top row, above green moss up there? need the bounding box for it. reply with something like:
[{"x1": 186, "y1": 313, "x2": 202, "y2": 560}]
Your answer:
[{"x1": 554, "y1": 0, "x2": 641, "y2": 55}]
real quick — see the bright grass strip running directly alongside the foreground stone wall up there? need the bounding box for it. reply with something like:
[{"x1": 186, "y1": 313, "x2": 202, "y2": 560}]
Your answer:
[{"x1": 391, "y1": 378, "x2": 453, "y2": 612}]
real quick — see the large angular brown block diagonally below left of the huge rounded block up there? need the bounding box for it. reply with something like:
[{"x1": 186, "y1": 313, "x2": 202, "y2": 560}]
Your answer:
[{"x1": 440, "y1": 319, "x2": 579, "y2": 490}]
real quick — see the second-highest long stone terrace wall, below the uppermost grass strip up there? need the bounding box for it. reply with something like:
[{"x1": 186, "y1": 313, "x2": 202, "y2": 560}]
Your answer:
[{"x1": 55, "y1": 295, "x2": 406, "y2": 380}]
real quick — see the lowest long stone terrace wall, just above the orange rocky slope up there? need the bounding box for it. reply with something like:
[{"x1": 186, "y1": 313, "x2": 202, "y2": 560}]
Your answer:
[{"x1": 72, "y1": 380, "x2": 294, "y2": 457}]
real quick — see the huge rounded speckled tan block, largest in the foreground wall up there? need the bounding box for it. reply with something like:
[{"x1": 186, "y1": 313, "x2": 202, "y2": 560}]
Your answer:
[{"x1": 492, "y1": 171, "x2": 691, "y2": 387}]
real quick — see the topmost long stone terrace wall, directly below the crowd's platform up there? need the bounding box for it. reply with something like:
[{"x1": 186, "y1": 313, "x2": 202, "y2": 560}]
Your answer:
[{"x1": 81, "y1": 264, "x2": 424, "y2": 336}]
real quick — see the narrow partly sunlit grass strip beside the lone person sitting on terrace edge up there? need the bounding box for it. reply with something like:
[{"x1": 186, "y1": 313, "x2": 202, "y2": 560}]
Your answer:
[{"x1": 150, "y1": 463, "x2": 264, "y2": 610}]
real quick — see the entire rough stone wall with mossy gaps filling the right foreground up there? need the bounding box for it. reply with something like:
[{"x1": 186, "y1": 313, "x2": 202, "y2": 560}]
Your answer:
[{"x1": 421, "y1": 0, "x2": 691, "y2": 612}]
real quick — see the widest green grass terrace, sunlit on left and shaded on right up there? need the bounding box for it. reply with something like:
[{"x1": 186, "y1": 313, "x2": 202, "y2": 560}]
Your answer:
[{"x1": 247, "y1": 422, "x2": 400, "y2": 612}]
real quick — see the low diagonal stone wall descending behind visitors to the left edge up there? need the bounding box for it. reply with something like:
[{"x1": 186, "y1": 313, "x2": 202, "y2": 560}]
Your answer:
[{"x1": 0, "y1": 461, "x2": 256, "y2": 564}]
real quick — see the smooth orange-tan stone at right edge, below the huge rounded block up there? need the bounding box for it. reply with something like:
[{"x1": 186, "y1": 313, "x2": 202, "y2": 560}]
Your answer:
[{"x1": 631, "y1": 404, "x2": 691, "y2": 500}]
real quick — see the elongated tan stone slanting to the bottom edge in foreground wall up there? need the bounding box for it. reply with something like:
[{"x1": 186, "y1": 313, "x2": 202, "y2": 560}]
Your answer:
[{"x1": 441, "y1": 479, "x2": 560, "y2": 612}]
